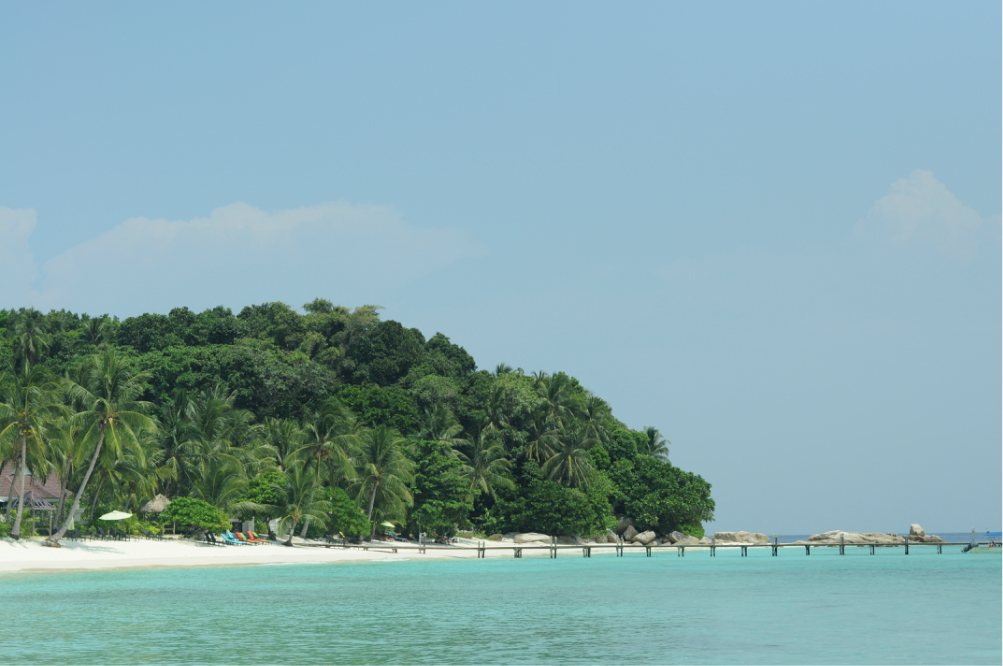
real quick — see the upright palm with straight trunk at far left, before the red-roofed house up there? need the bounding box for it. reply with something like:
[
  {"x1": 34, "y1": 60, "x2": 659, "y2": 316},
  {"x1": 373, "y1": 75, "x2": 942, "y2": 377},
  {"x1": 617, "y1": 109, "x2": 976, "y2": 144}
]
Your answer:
[{"x1": 0, "y1": 360, "x2": 61, "y2": 539}]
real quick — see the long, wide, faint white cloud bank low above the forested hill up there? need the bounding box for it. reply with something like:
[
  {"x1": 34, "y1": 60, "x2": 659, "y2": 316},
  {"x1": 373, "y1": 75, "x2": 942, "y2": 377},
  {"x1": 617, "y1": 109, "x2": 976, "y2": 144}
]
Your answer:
[{"x1": 0, "y1": 204, "x2": 480, "y2": 313}]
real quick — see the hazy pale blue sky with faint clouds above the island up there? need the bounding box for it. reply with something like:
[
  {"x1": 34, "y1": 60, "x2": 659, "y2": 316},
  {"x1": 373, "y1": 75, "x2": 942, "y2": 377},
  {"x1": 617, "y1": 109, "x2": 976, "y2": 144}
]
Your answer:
[{"x1": 0, "y1": 1, "x2": 1003, "y2": 534}]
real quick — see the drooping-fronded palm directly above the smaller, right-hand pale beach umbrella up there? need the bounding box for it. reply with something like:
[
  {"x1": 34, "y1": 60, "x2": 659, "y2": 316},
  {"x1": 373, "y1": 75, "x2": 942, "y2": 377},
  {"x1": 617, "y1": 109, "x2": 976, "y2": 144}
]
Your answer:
[{"x1": 356, "y1": 425, "x2": 414, "y2": 521}]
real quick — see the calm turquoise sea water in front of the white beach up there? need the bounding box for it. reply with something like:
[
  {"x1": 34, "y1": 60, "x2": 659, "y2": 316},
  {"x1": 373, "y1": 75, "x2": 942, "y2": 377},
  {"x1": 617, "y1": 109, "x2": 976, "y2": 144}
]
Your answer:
[{"x1": 0, "y1": 548, "x2": 1003, "y2": 664}]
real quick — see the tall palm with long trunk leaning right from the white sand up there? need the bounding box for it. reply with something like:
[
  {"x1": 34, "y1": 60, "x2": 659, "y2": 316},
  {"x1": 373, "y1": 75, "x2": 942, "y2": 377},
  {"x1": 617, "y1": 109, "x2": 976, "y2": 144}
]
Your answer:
[{"x1": 46, "y1": 349, "x2": 155, "y2": 546}]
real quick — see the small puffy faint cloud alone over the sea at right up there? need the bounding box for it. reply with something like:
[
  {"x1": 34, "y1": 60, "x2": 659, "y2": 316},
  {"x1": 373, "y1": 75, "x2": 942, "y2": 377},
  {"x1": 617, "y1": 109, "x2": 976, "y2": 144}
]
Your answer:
[{"x1": 855, "y1": 169, "x2": 982, "y2": 261}]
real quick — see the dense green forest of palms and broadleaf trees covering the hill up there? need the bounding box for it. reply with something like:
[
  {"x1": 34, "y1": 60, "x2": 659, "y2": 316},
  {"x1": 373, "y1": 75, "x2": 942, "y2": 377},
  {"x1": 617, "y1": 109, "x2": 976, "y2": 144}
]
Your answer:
[{"x1": 0, "y1": 299, "x2": 714, "y2": 539}]
